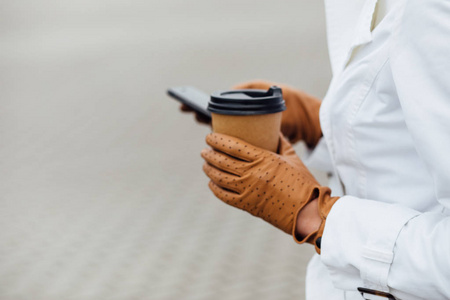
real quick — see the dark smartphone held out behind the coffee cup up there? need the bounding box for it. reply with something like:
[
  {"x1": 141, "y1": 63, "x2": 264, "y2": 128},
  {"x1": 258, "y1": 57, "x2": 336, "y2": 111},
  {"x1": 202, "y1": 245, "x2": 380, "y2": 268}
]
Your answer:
[{"x1": 167, "y1": 86, "x2": 211, "y2": 118}]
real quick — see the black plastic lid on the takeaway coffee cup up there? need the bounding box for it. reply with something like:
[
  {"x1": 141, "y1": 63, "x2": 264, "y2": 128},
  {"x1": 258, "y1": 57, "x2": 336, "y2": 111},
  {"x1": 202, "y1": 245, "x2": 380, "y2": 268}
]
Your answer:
[{"x1": 208, "y1": 86, "x2": 286, "y2": 116}]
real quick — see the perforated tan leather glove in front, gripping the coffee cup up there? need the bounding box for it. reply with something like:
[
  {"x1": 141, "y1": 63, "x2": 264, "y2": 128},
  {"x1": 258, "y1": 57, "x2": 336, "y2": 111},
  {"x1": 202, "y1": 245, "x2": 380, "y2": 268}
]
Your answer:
[{"x1": 201, "y1": 133, "x2": 338, "y2": 253}]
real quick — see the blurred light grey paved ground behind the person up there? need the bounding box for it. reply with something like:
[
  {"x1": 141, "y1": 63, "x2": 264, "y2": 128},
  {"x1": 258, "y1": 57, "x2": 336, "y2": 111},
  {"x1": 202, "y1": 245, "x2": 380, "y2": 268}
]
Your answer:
[{"x1": 0, "y1": 0, "x2": 331, "y2": 300}]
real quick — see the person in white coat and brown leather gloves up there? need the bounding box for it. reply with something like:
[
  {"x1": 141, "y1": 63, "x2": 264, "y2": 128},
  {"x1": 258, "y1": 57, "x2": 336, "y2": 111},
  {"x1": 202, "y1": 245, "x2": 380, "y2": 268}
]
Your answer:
[{"x1": 187, "y1": 0, "x2": 450, "y2": 299}]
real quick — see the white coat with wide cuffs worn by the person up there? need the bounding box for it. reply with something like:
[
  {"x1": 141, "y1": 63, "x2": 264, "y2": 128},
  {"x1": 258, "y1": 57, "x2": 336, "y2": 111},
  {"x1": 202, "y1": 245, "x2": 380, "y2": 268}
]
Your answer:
[{"x1": 306, "y1": 0, "x2": 450, "y2": 300}]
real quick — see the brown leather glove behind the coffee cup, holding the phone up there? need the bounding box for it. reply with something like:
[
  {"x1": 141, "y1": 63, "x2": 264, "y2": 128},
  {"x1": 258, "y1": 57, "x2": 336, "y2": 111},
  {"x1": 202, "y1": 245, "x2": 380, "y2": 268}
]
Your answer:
[{"x1": 234, "y1": 80, "x2": 322, "y2": 148}]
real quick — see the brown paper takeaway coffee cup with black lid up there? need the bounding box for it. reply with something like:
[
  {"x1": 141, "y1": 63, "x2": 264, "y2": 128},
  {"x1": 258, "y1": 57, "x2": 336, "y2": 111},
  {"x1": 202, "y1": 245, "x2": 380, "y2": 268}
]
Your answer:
[{"x1": 208, "y1": 86, "x2": 286, "y2": 152}]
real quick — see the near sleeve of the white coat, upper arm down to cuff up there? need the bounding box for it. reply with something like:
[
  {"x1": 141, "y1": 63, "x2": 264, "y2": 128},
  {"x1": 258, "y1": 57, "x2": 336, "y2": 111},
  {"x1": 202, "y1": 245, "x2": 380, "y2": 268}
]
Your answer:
[{"x1": 322, "y1": 0, "x2": 450, "y2": 299}]
